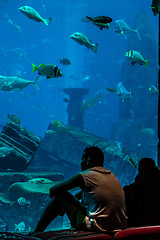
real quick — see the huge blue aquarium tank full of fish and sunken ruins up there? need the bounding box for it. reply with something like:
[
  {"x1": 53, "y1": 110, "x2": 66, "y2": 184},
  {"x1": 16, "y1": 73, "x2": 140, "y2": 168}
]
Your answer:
[{"x1": 0, "y1": 0, "x2": 159, "y2": 232}]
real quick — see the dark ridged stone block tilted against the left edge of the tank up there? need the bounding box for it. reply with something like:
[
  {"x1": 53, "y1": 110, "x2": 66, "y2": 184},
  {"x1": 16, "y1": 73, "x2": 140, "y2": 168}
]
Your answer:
[{"x1": 0, "y1": 121, "x2": 41, "y2": 171}]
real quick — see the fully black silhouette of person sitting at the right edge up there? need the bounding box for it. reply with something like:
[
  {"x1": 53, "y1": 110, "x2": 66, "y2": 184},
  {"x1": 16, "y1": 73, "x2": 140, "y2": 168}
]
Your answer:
[{"x1": 124, "y1": 158, "x2": 160, "y2": 227}]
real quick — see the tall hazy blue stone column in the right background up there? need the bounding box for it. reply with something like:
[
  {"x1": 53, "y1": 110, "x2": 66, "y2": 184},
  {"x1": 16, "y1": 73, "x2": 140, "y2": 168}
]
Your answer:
[{"x1": 120, "y1": 10, "x2": 158, "y2": 125}]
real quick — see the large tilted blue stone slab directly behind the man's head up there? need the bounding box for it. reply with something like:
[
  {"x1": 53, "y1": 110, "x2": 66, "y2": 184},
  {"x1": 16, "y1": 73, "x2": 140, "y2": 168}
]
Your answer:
[{"x1": 31, "y1": 121, "x2": 137, "y2": 184}]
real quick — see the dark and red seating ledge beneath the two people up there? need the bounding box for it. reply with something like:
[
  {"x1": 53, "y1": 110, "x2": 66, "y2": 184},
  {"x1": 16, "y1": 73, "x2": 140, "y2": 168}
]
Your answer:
[{"x1": 0, "y1": 226, "x2": 160, "y2": 240}]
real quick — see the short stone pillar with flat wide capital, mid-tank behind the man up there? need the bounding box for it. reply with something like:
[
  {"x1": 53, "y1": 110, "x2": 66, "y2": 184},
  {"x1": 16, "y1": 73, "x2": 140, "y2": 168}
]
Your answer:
[{"x1": 63, "y1": 88, "x2": 89, "y2": 130}]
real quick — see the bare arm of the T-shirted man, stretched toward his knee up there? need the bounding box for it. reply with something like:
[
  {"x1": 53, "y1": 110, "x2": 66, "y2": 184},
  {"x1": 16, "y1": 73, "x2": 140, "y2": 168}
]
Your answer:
[{"x1": 50, "y1": 174, "x2": 84, "y2": 198}]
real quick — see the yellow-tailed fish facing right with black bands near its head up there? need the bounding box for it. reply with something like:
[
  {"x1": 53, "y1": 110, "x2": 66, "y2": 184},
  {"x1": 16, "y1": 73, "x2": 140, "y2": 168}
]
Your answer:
[{"x1": 32, "y1": 63, "x2": 62, "y2": 79}]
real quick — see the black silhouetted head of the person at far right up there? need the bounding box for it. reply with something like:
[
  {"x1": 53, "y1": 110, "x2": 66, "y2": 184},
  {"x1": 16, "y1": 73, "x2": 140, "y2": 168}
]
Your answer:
[{"x1": 138, "y1": 157, "x2": 158, "y2": 173}]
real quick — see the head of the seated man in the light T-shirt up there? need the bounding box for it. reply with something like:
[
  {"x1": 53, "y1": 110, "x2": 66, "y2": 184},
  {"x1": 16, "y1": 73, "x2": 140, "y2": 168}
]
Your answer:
[{"x1": 81, "y1": 146, "x2": 104, "y2": 171}]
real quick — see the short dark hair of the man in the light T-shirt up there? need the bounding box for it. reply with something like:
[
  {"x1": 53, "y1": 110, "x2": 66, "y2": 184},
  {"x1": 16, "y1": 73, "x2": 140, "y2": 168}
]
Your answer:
[{"x1": 83, "y1": 146, "x2": 104, "y2": 166}]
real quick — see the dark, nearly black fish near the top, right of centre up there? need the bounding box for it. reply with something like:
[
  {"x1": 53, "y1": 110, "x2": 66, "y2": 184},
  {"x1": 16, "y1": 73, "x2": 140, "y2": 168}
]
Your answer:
[{"x1": 86, "y1": 16, "x2": 112, "y2": 30}]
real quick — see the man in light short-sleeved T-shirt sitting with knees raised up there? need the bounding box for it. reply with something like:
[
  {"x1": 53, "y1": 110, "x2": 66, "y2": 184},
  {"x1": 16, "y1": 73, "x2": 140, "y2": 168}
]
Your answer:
[{"x1": 31, "y1": 146, "x2": 127, "y2": 235}]
